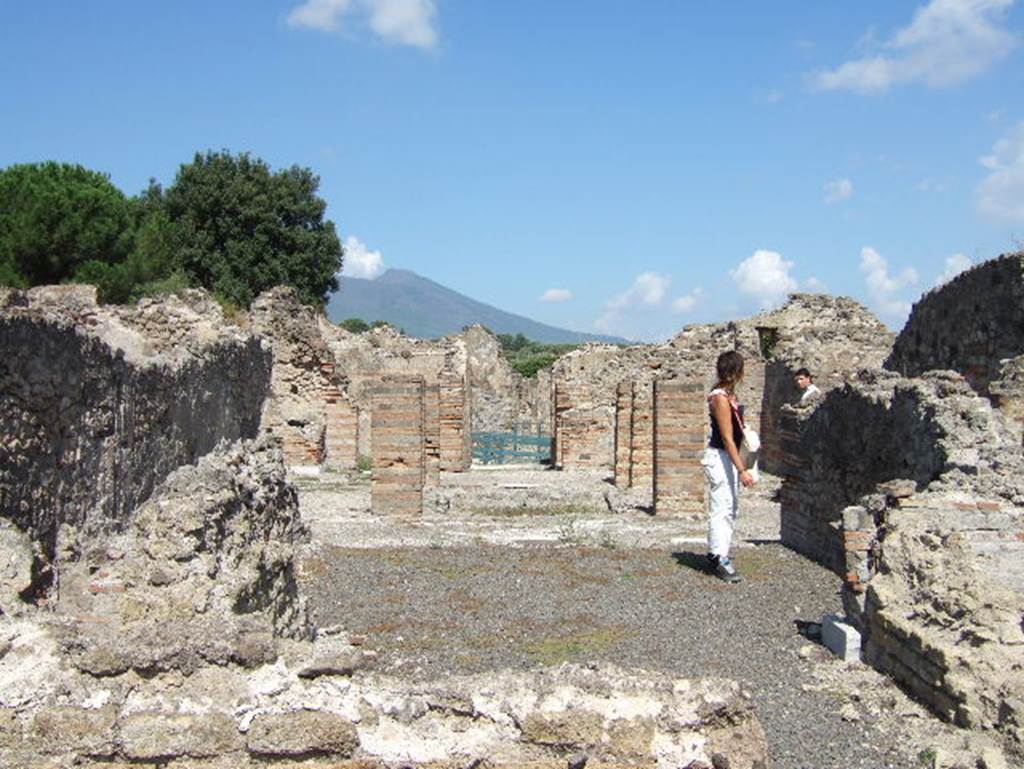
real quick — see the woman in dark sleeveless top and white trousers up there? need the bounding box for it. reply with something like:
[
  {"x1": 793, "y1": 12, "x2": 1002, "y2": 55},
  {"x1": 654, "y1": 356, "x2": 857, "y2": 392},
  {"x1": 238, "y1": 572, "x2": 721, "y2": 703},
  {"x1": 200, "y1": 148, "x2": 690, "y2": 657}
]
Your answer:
[{"x1": 700, "y1": 350, "x2": 757, "y2": 583}]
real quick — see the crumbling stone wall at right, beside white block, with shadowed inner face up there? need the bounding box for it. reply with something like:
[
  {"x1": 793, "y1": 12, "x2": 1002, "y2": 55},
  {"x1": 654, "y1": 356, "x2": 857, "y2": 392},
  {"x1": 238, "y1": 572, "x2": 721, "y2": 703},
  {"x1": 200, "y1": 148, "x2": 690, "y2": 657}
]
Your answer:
[{"x1": 781, "y1": 370, "x2": 1024, "y2": 758}]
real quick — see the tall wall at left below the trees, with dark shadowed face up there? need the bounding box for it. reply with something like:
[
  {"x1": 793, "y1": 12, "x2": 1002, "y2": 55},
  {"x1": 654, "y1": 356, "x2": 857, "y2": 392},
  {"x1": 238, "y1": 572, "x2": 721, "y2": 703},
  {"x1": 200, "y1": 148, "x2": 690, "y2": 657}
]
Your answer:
[{"x1": 0, "y1": 287, "x2": 270, "y2": 583}]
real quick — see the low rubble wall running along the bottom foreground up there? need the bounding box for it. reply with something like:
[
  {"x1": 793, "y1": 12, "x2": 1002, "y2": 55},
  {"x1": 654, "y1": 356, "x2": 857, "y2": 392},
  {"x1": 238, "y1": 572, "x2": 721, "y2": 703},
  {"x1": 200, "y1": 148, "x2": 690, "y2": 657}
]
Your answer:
[{"x1": 0, "y1": 636, "x2": 768, "y2": 769}]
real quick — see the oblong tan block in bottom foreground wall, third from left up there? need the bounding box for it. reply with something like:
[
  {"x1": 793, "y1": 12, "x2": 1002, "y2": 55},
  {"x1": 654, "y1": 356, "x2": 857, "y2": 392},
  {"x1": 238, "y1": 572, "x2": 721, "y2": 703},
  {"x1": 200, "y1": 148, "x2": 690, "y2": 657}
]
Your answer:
[{"x1": 246, "y1": 711, "x2": 359, "y2": 758}]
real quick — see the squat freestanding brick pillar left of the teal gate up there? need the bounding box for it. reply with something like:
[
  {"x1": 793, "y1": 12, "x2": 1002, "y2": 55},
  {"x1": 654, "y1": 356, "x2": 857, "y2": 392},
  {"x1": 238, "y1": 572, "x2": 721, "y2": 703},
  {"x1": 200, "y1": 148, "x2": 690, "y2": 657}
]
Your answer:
[{"x1": 370, "y1": 377, "x2": 425, "y2": 515}]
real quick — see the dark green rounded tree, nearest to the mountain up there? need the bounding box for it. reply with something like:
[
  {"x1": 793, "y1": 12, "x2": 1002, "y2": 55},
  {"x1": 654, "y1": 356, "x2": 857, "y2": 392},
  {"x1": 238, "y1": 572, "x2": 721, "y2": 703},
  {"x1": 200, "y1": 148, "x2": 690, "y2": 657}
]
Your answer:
[{"x1": 163, "y1": 151, "x2": 343, "y2": 307}]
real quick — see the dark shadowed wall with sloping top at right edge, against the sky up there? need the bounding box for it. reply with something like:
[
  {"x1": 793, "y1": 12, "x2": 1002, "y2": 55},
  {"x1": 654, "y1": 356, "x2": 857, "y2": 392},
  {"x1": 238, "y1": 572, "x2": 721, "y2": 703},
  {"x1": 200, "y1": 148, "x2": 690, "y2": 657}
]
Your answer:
[{"x1": 885, "y1": 251, "x2": 1024, "y2": 395}]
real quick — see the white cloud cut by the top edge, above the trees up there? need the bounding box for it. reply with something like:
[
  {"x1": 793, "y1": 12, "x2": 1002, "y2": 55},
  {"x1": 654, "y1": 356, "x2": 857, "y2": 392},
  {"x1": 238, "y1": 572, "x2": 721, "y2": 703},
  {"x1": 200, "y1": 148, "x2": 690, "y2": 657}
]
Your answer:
[{"x1": 288, "y1": 0, "x2": 437, "y2": 49}]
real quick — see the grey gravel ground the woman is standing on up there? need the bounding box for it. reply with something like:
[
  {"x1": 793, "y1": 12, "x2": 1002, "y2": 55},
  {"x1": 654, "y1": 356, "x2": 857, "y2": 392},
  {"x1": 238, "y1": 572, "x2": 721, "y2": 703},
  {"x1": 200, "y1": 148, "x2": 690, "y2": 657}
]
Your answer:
[{"x1": 300, "y1": 466, "x2": 966, "y2": 769}]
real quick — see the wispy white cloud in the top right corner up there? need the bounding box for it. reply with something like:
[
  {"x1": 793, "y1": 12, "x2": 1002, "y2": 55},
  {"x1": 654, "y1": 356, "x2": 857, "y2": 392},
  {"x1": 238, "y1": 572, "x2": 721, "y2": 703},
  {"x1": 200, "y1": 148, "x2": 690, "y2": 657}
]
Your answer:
[{"x1": 811, "y1": 0, "x2": 1017, "y2": 93}]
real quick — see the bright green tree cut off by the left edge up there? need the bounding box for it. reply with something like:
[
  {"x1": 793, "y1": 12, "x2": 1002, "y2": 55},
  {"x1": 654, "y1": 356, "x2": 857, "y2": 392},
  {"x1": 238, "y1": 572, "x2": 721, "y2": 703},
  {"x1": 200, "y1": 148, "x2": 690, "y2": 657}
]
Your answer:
[{"x1": 0, "y1": 161, "x2": 132, "y2": 287}]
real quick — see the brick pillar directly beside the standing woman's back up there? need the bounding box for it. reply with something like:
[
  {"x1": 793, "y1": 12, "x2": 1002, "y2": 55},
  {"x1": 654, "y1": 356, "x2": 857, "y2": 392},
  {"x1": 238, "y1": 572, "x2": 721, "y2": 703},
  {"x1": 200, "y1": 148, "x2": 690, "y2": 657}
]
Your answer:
[{"x1": 653, "y1": 380, "x2": 708, "y2": 515}]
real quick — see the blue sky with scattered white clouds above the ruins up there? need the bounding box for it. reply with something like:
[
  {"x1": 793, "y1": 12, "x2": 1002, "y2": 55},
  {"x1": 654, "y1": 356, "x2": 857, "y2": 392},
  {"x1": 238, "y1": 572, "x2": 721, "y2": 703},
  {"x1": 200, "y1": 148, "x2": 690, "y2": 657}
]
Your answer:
[{"x1": 0, "y1": 0, "x2": 1024, "y2": 340}]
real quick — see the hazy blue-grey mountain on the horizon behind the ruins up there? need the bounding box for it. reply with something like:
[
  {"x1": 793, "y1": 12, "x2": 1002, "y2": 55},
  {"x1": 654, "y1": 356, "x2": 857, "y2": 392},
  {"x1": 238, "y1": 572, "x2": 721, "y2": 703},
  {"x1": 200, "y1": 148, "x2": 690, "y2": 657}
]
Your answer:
[{"x1": 327, "y1": 269, "x2": 628, "y2": 344}]
